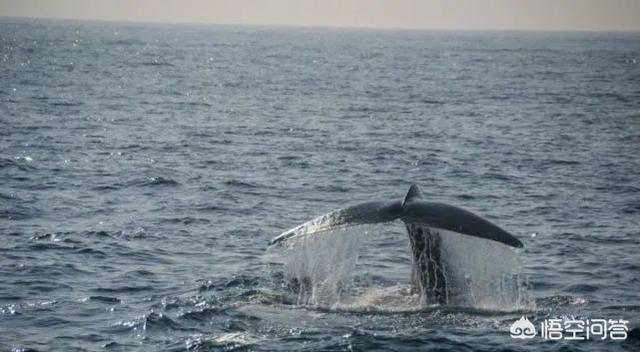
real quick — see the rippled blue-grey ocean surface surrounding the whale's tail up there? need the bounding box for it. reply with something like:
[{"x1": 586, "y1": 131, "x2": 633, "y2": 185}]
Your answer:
[{"x1": 0, "y1": 18, "x2": 640, "y2": 351}]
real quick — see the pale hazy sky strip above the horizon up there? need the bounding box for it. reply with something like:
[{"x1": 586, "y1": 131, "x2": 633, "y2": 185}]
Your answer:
[{"x1": 0, "y1": 0, "x2": 640, "y2": 31}]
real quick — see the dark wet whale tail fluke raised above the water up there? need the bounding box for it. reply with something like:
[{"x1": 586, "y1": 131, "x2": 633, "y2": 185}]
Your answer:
[{"x1": 269, "y1": 184, "x2": 524, "y2": 305}]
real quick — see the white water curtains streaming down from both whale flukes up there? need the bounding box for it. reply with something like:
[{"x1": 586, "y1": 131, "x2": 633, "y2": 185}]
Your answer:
[{"x1": 268, "y1": 225, "x2": 535, "y2": 312}]
